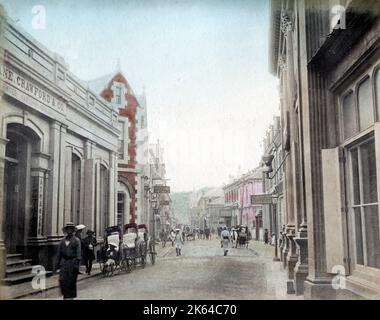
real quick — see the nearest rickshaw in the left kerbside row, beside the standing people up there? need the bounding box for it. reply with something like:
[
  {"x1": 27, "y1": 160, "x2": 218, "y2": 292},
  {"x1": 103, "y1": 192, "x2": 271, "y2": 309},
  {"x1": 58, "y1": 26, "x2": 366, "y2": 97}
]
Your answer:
[{"x1": 98, "y1": 226, "x2": 123, "y2": 277}]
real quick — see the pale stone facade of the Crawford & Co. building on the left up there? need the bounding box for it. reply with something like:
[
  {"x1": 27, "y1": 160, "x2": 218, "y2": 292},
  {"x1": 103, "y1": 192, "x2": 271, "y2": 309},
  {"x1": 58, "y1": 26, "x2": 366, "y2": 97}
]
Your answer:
[{"x1": 0, "y1": 11, "x2": 120, "y2": 270}]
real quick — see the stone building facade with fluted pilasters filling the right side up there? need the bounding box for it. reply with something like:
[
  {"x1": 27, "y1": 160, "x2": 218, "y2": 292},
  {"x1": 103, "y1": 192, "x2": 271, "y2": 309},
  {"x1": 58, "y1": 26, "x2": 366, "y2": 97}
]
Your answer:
[{"x1": 270, "y1": 0, "x2": 380, "y2": 299}]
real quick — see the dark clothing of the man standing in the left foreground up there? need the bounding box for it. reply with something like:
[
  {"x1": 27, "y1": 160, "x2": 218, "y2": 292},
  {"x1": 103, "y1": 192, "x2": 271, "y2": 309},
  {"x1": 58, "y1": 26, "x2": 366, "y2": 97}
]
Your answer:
[{"x1": 56, "y1": 236, "x2": 81, "y2": 299}]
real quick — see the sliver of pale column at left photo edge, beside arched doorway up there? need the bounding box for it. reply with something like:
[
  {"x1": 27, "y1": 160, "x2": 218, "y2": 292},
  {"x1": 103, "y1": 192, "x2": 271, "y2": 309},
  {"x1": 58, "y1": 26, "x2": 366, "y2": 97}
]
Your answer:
[{"x1": 0, "y1": 137, "x2": 9, "y2": 279}]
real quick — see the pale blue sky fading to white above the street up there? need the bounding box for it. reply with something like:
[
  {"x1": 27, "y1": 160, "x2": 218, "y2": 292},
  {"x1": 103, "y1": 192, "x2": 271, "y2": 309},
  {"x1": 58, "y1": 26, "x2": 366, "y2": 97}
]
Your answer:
[{"x1": 0, "y1": 0, "x2": 279, "y2": 192}]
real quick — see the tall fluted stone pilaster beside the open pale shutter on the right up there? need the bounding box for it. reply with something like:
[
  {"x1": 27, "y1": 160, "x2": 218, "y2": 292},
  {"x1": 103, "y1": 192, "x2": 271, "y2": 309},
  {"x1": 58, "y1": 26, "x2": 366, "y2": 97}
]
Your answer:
[{"x1": 298, "y1": 0, "x2": 336, "y2": 299}]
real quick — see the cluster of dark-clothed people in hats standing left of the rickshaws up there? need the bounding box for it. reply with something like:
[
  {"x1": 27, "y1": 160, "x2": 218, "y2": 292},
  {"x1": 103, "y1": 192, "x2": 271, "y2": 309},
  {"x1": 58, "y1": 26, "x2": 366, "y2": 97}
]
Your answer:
[{"x1": 55, "y1": 222, "x2": 97, "y2": 299}]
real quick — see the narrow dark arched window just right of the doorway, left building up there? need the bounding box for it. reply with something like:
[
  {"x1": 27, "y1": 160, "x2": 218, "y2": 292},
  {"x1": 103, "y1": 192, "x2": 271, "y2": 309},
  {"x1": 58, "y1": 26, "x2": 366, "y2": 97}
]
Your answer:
[{"x1": 71, "y1": 153, "x2": 82, "y2": 224}]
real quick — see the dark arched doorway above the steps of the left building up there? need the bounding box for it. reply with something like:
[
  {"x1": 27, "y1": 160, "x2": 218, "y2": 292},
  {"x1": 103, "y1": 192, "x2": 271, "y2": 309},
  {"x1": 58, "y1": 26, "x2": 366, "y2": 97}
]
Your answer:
[{"x1": 4, "y1": 123, "x2": 40, "y2": 253}]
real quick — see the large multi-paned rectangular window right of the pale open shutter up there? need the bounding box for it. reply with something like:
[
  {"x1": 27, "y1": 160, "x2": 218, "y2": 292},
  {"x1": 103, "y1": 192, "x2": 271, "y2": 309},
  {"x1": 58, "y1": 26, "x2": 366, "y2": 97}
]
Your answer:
[{"x1": 349, "y1": 137, "x2": 380, "y2": 269}]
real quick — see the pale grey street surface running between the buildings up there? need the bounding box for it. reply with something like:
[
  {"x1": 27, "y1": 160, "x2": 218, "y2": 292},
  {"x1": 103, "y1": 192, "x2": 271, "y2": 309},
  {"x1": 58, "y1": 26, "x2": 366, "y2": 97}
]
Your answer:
[{"x1": 27, "y1": 239, "x2": 302, "y2": 300}]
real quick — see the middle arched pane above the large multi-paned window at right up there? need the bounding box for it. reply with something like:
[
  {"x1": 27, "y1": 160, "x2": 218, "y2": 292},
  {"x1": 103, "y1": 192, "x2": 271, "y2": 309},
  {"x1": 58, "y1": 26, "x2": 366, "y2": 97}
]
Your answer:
[{"x1": 358, "y1": 77, "x2": 374, "y2": 130}]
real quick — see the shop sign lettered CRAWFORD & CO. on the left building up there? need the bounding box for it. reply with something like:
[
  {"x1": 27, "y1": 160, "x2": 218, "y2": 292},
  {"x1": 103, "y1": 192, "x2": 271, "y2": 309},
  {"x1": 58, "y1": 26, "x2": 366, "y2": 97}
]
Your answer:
[{"x1": 0, "y1": 64, "x2": 66, "y2": 115}]
